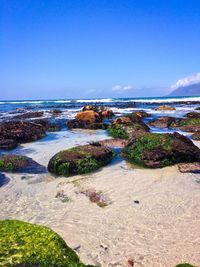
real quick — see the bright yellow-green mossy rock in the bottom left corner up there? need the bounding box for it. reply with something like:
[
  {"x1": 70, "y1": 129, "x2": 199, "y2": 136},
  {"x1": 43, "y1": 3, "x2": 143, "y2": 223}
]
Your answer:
[{"x1": 0, "y1": 220, "x2": 94, "y2": 267}]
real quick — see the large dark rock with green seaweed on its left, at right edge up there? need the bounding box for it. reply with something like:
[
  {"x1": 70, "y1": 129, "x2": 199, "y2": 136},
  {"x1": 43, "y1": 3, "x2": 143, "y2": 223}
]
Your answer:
[{"x1": 122, "y1": 133, "x2": 200, "y2": 168}]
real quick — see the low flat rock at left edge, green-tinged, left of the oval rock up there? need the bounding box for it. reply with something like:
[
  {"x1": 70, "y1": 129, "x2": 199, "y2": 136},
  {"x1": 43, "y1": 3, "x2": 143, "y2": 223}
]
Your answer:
[{"x1": 0, "y1": 154, "x2": 45, "y2": 173}]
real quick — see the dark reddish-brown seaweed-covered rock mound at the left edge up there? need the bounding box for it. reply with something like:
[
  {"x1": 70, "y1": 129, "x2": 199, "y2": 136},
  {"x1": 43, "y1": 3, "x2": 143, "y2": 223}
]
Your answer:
[{"x1": 0, "y1": 121, "x2": 45, "y2": 148}]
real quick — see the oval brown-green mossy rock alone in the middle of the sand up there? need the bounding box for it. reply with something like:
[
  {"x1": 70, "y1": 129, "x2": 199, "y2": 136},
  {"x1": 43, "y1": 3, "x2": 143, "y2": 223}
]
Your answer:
[{"x1": 48, "y1": 144, "x2": 113, "y2": 176}]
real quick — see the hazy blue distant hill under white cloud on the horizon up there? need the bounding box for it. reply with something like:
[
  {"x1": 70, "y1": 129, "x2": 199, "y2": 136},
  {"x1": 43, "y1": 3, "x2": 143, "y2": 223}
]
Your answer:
[{"x1": 169, "y1": 83, "x2": 200, "y2": 96}]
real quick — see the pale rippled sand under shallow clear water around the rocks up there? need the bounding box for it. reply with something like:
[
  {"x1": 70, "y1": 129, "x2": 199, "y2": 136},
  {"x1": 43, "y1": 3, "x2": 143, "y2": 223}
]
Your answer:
[{"x1": 0, "y1": 131, "x2": 200, "y2": 267}]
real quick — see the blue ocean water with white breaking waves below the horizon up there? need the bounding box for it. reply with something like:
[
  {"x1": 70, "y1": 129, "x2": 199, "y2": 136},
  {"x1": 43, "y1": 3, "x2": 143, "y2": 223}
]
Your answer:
[{"x1": 0, "y1": 96, "x2": 200, "y2": 120}]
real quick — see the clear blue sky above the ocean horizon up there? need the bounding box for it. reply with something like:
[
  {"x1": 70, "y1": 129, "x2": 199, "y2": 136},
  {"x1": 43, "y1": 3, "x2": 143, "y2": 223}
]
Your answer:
[{"x1": 0, "y1": 0, "x2": 200, "y2": 99}]
